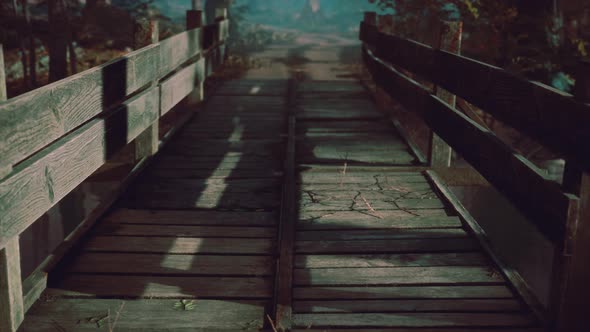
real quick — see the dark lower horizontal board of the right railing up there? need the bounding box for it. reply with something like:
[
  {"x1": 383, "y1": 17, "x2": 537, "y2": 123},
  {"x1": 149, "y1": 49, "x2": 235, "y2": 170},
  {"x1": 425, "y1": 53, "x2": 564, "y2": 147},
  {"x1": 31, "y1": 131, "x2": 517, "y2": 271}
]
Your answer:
[{"x1": 364, "y1": 49, "x2": 575, "y2": 241}]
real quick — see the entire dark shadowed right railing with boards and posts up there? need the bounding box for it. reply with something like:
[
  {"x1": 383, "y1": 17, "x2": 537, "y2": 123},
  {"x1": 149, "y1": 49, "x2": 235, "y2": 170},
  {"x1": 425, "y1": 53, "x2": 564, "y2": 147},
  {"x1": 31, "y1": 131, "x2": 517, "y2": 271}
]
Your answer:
[{"x1": 360, "y1": 13, "x2": 590, "y2": 331}]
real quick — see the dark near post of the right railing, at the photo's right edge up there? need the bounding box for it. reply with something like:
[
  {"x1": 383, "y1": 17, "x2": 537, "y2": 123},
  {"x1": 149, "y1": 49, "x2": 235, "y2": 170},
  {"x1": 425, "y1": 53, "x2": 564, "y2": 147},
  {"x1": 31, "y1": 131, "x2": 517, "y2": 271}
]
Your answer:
[{"x1": 550, "y1": 63, "x2": 590, "y2": 332}]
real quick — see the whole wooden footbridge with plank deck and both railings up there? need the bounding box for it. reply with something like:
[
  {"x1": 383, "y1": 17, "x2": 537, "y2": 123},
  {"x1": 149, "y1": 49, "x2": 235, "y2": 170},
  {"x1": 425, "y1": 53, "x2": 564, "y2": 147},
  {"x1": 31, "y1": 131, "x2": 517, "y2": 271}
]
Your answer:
[{"x1": 0, "y1": 10, "x2": 590, "y2": 332}]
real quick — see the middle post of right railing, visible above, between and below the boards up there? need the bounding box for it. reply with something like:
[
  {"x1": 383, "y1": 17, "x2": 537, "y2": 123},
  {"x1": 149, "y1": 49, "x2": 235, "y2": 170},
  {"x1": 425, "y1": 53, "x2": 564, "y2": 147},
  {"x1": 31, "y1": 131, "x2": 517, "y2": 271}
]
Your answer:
[{"x1": 429, "y1": 21, "x2": 463, "y2": 168}]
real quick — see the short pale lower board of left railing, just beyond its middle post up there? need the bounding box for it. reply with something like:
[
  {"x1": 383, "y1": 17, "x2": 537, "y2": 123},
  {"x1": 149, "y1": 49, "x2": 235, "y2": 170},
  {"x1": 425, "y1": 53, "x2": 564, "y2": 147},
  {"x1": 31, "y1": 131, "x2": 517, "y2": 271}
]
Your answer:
[{"x1": 160, "y1": 59, "x2": 205, "y2": 115}]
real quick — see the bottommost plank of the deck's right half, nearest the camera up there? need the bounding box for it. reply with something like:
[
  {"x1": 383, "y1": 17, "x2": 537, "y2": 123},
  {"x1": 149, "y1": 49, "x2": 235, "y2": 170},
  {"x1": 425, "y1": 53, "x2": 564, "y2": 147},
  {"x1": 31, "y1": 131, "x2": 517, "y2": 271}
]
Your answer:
[{"x1": 294, "y1": 313, "x2": 535, "y2": 327}]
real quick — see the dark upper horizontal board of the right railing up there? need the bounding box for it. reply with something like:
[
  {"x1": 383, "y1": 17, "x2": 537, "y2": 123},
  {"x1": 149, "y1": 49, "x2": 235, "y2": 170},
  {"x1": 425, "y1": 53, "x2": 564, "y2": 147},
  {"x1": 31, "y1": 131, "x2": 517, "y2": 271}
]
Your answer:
[{"x1": 361, "y1": 23, "x2": 590, "y2": 170}]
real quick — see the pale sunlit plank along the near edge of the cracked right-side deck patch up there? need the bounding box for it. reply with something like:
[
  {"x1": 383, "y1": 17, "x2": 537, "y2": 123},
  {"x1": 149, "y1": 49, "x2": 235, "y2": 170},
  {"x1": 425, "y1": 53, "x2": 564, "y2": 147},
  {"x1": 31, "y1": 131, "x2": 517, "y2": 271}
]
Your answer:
[{"x1": 297, "y1": 214, "x2": 462, "y2": 231}]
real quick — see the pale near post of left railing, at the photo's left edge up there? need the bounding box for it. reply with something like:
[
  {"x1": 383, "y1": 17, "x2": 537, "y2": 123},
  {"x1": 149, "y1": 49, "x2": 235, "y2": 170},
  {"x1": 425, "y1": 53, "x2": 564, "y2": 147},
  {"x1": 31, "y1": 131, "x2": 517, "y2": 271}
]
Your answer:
[{"x1": 0, "y1": 44, "x2": 25, "y2": 332}]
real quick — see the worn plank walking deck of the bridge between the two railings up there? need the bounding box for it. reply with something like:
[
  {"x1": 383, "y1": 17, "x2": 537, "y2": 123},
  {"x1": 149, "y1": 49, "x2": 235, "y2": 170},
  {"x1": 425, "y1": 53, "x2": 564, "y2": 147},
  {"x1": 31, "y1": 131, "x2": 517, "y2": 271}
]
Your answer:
[{"x1": 22, "y1": 80, "x2": 536, "y2": 332}]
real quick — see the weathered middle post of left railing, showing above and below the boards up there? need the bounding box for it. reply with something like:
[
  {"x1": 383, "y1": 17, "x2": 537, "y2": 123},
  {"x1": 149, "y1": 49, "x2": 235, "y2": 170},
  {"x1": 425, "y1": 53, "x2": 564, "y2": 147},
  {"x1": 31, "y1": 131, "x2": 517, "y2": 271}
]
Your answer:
[{"x1": 133, "y1": 19, "x2": 160, "y2": 162}]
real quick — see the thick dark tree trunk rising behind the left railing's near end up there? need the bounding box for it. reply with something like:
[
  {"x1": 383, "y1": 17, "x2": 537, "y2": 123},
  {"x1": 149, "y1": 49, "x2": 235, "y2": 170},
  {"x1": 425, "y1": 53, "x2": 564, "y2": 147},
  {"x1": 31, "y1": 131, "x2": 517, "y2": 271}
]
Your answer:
[{"x1": 48, "y1": 0, "x2": 69, "y2": 82}]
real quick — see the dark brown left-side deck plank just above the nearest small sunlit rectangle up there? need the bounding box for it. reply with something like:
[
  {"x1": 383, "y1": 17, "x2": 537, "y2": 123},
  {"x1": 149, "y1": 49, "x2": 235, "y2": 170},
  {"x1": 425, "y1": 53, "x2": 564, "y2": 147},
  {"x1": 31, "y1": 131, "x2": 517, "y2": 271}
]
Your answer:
[{"x1": 94, "y1": 224, "x2": 276, "y2": 238}]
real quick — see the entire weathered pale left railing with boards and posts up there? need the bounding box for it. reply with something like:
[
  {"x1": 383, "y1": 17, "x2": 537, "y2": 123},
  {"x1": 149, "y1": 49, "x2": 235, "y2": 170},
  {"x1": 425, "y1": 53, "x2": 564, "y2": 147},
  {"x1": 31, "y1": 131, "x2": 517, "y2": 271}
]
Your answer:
[{"x1": 0, "y1": 7, "x2": 229, "y2": 331}]
